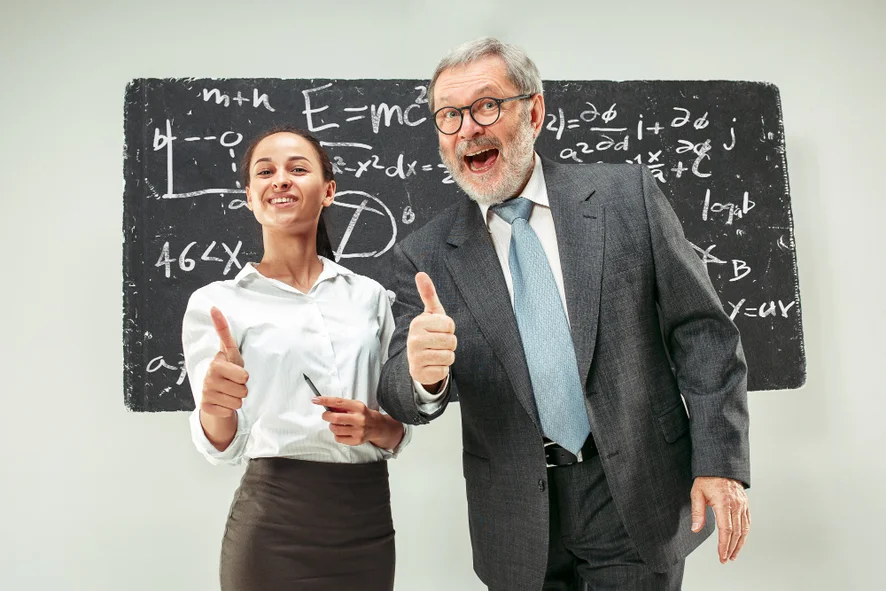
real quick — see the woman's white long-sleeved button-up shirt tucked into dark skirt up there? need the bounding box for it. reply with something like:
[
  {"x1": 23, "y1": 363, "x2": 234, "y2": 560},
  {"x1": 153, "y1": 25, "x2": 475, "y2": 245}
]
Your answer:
[{"x1": 182, "y1": 257, "x2": 412, "y2": 464}]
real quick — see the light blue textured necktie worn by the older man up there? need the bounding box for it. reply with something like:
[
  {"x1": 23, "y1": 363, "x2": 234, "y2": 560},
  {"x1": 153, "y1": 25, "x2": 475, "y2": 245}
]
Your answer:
[{"x1": 492, "y1": 197, "x2": 591, "y2": 455}]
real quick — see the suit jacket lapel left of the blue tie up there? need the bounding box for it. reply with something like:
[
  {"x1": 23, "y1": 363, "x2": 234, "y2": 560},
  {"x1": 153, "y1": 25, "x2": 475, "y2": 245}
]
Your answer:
[{"x1": 446, "y1": 198, "x2": 541, "y2": 432}]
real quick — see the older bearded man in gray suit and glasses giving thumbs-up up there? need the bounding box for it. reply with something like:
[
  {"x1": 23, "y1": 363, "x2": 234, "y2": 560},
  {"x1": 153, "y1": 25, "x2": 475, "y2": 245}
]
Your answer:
[{"x1": 379, "y1": 39, "x2": 750, "y2": 591}]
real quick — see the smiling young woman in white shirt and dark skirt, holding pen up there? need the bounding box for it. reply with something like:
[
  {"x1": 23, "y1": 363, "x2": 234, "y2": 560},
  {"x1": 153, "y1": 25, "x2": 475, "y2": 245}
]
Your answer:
[{"x1": 182, "y1": 128, "x2": 410, "y2": 591}]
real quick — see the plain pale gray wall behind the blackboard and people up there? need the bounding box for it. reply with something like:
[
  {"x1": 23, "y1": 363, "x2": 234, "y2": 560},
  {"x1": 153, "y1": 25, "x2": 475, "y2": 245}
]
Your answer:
[{"x1": 0, "y1": 0, "x2": 886, "y2": 591}]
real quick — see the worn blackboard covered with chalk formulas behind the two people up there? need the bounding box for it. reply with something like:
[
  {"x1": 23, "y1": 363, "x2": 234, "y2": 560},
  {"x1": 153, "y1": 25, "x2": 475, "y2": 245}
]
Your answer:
[{"x1": 123, "y1": 79, "x2": 806, "y2": 411}]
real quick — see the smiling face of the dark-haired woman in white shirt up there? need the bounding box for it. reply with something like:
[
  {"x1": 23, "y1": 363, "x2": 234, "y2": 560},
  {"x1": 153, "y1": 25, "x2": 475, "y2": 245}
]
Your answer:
[{"x1": 246, "y1": 132, "x2": 335, "y2": 232}]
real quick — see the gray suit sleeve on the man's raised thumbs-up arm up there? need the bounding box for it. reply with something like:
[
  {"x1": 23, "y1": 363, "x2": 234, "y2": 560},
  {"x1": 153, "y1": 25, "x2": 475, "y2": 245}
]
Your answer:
[{"x1": 378, "y1": 244, "x2": 452, "y2": 425}]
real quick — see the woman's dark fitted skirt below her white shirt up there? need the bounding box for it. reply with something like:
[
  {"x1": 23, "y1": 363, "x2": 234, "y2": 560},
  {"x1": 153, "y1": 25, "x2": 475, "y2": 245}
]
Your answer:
[{"x1": 221, "y1": 458, "x2": 394, "y2": 591}]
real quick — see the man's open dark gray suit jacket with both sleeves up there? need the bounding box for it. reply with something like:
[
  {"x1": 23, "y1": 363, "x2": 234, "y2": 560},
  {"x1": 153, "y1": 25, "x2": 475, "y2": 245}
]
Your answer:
[{"x1": 378, "y1": 159, "x2": 750, "y2": 591}]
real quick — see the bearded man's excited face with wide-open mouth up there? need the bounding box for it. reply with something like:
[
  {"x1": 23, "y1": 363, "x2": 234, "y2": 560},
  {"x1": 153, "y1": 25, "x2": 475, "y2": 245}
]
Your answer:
[{"x1": 434, "y1": 57, "x2": 544, "y2": 205}]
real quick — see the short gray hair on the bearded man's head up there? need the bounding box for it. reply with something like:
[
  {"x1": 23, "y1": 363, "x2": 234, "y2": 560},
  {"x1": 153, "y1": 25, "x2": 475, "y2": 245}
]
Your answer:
[{"x1": 428, "y1": 37, "x2": 543, "y2": 113}]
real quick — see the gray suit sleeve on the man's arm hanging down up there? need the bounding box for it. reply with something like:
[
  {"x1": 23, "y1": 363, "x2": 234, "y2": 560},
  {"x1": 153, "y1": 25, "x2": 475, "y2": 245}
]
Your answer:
[{"x1": 642, "y1": 167, "x2": 751, "y2": 487}]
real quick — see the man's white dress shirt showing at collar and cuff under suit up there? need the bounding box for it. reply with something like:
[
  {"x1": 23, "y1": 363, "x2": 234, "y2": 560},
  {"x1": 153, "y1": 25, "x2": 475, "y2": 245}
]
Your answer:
[{"x1": 413, "y1": 154, "x2": 569, "y2": 415}]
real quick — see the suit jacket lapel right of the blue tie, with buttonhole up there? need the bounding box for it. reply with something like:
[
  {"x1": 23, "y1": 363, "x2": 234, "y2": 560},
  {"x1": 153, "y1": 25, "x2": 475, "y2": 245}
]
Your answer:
[{"x1": 542, "y1": 158, "x2": 604, "y2": 385}]
